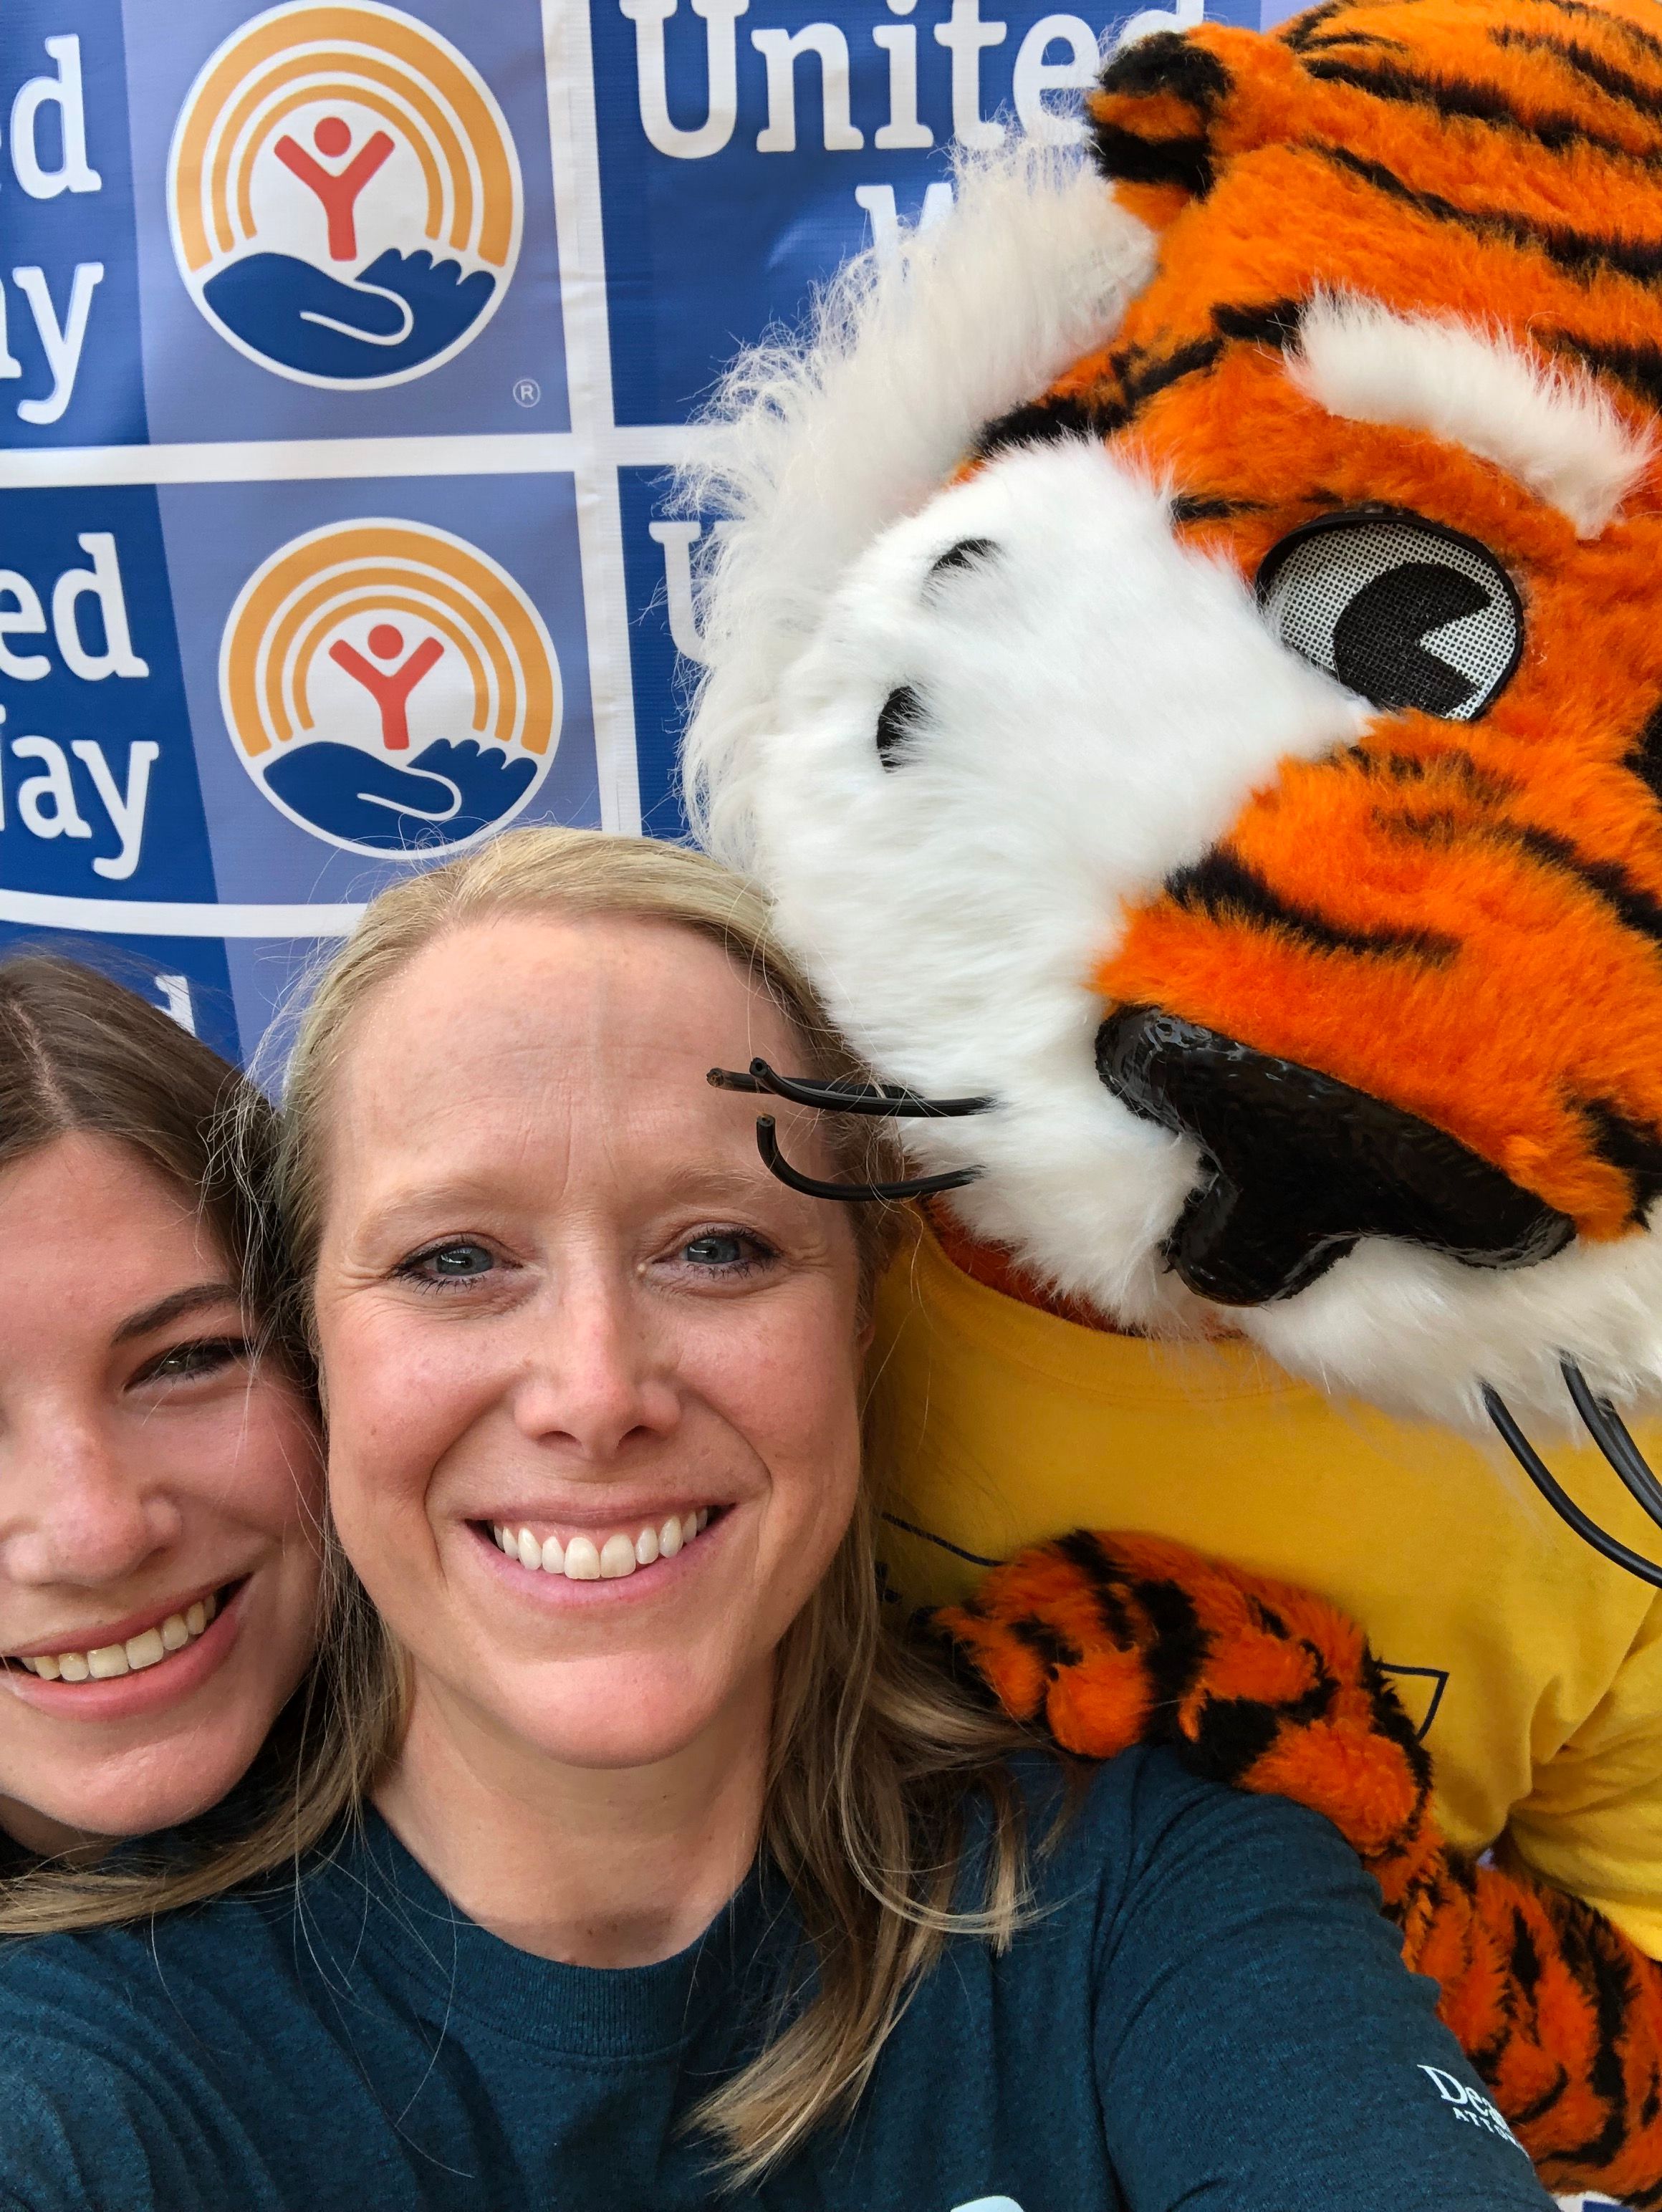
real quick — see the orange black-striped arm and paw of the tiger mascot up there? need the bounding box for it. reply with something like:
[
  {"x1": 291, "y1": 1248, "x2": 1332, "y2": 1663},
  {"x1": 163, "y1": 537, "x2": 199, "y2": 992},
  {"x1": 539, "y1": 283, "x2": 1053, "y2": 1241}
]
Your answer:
[{"x1": 938, "y1": 1531, "x2": 1662, "y2": 2206}]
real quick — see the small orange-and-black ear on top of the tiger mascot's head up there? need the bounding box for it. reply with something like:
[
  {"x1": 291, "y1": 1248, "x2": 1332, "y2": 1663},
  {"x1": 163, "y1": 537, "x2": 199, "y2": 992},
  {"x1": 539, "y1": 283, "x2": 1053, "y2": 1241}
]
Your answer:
[{"x1": 1087, "y1": 24, "x2": 1297, "y2": 230}]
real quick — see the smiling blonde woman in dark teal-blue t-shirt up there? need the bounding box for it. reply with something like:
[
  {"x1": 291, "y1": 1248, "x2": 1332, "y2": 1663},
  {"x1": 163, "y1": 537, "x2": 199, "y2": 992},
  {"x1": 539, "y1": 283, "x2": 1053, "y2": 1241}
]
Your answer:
[{"x1": 0, "y1": 830, "x2": 1547, "y2": 2212}]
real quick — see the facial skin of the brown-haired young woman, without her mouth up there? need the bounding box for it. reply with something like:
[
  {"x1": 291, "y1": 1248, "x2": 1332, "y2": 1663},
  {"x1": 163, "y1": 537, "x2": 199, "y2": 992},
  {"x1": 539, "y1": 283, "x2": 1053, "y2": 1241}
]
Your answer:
[{"x1": 0, "y1": 1135, "x2": 321, "y2": 1850}]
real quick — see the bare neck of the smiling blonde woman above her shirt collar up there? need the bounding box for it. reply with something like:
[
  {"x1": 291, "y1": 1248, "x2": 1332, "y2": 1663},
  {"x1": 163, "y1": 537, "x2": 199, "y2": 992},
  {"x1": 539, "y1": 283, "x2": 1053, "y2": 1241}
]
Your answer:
[{"x1": 374, "y1": 1670, "x2": 772, "y2": 1966}]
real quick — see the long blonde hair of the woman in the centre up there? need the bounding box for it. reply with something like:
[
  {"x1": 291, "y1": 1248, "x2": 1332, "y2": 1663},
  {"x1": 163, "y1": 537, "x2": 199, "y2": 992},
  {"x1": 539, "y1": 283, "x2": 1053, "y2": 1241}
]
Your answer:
[{"x1": 0, "y1": 830, "x2": 1027, "y2": 2183}]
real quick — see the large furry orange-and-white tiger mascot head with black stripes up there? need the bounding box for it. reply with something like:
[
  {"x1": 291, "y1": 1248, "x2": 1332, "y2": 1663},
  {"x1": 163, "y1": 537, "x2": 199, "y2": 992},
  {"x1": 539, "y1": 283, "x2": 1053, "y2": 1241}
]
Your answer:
[{"x1": 688, "y1": 0, "x2": 1662, "y2": 1460}]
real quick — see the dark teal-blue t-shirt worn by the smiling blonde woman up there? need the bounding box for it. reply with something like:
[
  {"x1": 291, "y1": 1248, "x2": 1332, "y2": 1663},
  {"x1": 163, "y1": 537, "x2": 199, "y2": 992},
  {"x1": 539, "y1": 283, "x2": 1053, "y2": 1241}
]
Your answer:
[{"x1": 0, "y1": 1752, "x2": 1549, "y2": 2212}]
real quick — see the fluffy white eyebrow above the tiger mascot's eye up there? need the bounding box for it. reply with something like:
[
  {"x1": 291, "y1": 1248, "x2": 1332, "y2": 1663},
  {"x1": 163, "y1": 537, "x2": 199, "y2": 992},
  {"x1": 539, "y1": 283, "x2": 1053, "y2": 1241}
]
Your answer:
[{"x1": 1290, "y1": 292, "x2": 1651, "y2": 537}]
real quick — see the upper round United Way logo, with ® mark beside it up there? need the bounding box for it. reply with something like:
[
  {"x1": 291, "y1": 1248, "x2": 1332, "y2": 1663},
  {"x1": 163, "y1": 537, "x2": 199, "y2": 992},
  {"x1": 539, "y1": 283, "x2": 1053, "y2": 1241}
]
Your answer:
[{"x1": 168, "y1": 0, "x2": 522, "y2": 389}]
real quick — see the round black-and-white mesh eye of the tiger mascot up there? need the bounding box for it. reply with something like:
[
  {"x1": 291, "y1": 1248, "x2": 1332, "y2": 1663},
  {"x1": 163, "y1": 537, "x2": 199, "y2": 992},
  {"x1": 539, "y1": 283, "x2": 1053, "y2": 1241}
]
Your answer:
[{"x1": 1257, "y1": 511, "x2": 1522, "y2": 721}]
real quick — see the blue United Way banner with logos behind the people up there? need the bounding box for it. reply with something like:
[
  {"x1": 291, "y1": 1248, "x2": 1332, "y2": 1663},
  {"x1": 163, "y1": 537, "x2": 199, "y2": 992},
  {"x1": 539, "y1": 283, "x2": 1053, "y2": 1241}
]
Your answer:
[{"x1": 0, "y1": 0, "x2": 1290, "y2": 1055}]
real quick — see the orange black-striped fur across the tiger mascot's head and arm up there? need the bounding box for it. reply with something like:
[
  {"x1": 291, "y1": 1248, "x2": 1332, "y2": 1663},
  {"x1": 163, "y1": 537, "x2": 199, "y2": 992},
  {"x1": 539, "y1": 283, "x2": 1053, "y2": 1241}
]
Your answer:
[{"x1": 943, "y1": 13, "x2": 1662, "y2": 2206}]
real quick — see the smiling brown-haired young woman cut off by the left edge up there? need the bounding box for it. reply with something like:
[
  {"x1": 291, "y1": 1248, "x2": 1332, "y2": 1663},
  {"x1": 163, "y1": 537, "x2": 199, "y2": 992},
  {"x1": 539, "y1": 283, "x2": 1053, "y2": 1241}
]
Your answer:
[{"x1": 0, "y1": 953, "x2": 321, "y2": 1933}]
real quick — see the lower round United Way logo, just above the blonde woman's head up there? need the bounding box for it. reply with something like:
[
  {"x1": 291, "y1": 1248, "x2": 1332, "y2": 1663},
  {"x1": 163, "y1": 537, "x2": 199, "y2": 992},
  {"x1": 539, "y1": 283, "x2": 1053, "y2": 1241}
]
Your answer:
[{"x1": 219, "y1": 520, "x2": 560, "y2": 856}]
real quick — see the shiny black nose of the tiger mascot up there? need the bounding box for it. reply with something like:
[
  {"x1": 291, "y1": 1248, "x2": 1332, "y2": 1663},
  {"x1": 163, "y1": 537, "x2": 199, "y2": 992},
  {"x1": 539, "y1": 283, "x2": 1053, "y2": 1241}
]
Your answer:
[{"x1": 1095, "y1": 1006, "x2": 1576, "y2": 1305}]
